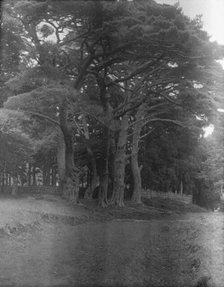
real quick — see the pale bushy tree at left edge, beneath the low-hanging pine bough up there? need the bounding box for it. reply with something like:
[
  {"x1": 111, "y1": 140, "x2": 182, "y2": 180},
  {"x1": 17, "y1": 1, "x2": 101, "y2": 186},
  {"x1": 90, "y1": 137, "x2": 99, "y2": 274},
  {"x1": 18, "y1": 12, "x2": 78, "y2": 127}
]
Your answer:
[{"x1": 0, "y1": 109, "x2": 35, "y2": 190}]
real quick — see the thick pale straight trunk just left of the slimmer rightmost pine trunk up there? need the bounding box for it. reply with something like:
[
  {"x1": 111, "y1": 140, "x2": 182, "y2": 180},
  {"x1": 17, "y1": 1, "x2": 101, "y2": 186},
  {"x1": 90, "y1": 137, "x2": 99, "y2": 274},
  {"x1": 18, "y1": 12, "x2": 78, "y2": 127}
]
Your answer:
[{"x1": 111, "y1": 115, "x2": 128, "y2": 207}]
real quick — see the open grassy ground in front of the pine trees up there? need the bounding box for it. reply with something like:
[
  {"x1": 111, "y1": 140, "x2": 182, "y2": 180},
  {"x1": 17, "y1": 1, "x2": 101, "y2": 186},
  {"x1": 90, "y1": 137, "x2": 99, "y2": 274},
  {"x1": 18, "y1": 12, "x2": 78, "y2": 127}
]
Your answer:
[{"x1": 0, "y1": 195, "x2": 224, "y2": 287}]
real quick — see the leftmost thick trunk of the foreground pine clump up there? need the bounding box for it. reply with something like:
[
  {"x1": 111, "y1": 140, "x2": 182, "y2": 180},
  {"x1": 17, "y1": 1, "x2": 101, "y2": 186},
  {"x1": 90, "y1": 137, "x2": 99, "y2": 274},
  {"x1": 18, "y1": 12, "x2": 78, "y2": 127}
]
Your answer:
[{"x1": 60, "y1": 99, "x2": 79, "y2": 203}]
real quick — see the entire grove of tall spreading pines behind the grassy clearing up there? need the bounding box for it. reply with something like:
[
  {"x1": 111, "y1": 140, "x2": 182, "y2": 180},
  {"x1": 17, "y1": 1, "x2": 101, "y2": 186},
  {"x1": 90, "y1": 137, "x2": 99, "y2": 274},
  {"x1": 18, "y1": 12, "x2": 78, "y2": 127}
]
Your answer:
[{"x1": 0, "y1": 0, "x2": 224, "y2": 207}]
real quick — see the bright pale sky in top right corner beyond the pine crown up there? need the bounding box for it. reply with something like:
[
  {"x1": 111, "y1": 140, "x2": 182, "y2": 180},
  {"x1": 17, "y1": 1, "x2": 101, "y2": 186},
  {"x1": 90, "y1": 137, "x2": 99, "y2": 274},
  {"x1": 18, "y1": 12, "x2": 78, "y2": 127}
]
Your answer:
[{"x1": 156, "y1": 0, "x2": 224, "y2": 44}]
